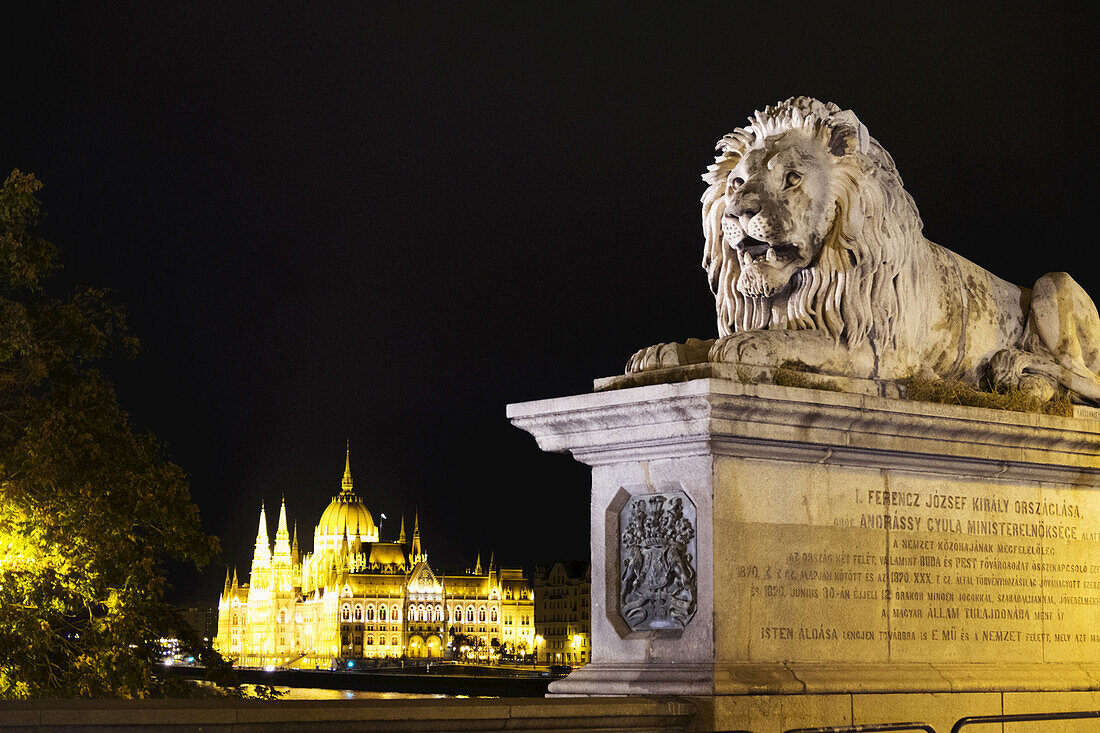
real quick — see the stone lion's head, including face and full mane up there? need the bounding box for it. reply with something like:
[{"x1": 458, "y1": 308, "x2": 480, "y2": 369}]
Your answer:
[{"x1": 702, "y1": 97, "x2": 922, "y2": 346}]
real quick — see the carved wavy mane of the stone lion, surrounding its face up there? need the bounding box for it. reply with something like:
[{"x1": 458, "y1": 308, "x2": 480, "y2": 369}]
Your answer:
[{"x1": 702, "y1": 97, "x2": 926, "y2": 348}]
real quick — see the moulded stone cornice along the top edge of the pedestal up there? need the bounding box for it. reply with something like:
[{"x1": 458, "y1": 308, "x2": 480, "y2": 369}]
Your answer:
[{"x1": 508, "y1": 379, "x2": 1100, "y2": 485}]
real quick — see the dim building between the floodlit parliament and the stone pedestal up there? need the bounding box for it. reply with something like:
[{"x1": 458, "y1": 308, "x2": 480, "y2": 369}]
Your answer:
[{"x1": 535, "y1": 562, "x2": 592, "y2": 667}]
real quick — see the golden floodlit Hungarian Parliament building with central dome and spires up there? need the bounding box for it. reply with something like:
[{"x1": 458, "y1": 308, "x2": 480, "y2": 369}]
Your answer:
[{"x1": 215, "y1": 453, "x2": 536, "y2": 669}]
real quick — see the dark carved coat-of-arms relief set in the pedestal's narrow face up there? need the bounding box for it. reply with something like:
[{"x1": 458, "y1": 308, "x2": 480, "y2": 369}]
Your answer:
[{"x1": 619, "y1": 491, "x2": 697, "y2": 631}]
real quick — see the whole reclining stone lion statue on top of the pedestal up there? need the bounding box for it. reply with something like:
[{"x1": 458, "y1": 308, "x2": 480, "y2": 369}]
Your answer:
[{"x1": 627, "y1": 97, "x2": 1100, "y2": 404}]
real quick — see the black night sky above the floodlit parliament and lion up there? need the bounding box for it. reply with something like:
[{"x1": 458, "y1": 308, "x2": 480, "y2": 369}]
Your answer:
[{"x1": 0, "y1": 2, "x2": 1100, "y2": 603}]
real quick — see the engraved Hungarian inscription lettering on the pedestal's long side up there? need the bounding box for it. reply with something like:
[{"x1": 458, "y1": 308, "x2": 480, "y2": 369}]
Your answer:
[{"x1": 733, "y1": 475, "x2": 1100, "y2": 661}]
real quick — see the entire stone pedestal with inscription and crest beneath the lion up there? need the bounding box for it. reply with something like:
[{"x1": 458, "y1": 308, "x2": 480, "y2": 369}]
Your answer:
[{"x1": 508, "y1": 368, "x2": 1100, "y2": 725}]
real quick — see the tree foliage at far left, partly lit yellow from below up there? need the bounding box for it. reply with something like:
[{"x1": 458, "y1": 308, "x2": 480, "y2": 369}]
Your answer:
[{"x1": 0, "y1": 171, "x2": 217, "y2": 698}]
